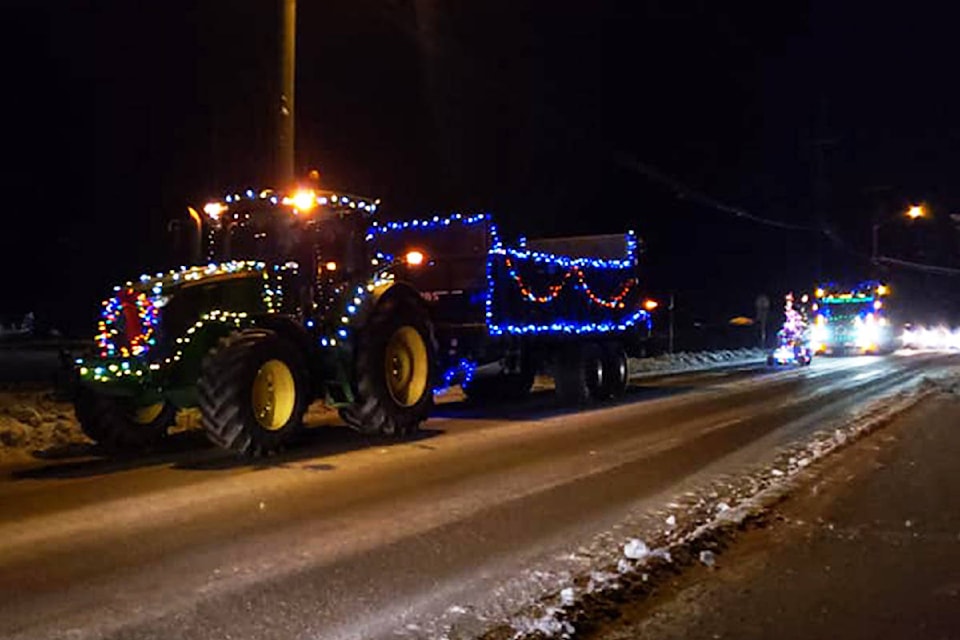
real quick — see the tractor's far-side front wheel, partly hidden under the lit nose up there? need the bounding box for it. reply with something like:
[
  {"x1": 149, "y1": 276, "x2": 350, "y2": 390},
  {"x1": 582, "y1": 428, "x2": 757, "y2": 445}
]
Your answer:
[{"x1": 74, "y1": 387, "x2": 177, "y2": 452}]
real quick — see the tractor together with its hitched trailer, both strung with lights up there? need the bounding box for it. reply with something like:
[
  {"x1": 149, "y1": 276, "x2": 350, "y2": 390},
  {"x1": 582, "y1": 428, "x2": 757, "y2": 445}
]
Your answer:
[{"x1": 65, "y1": 185, "x2": 655, "y2": 456}]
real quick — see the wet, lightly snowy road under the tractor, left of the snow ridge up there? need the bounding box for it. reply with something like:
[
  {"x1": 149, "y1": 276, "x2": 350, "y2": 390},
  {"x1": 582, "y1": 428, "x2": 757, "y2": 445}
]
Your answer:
[{"x1": 0, "y1": 354, "x2": 957, "y2": 639}]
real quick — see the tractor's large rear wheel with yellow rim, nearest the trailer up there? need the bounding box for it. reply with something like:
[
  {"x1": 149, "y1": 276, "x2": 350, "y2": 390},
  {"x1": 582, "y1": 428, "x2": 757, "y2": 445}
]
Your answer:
[{"x1": 340, "y1": 295, "x2": 437, "y2": 436}]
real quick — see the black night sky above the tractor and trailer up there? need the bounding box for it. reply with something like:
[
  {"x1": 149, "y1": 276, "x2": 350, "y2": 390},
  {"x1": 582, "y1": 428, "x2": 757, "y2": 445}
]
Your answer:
[{"x1": 0, "y1": 0, "x2": 960, "y2": 332}]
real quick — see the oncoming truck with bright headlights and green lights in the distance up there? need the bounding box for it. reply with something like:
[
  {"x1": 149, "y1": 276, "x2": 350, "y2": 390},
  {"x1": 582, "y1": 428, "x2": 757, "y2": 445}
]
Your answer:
[{"x1": 811, "y1": 280, "x2": 897, "y2": 355}]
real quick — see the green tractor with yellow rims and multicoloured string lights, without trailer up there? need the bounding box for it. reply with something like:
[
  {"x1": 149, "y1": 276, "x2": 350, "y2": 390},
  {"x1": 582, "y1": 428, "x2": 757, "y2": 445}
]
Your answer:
[{"x1": 72, "y1": 190, "x2": 437, "y2": 456}]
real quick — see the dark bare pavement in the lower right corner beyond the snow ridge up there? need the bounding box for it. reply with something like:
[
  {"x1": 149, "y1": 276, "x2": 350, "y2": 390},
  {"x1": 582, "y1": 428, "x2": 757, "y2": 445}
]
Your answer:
[{"x1": 588, "y1": 384, "x2": 960, "y2": 640}]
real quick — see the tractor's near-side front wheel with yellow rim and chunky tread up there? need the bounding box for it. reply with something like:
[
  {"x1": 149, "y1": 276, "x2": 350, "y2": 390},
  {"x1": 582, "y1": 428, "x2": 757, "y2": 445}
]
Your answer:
[{"x1": 197, "y1": 329, "x2": 310, "y2": 457}]
